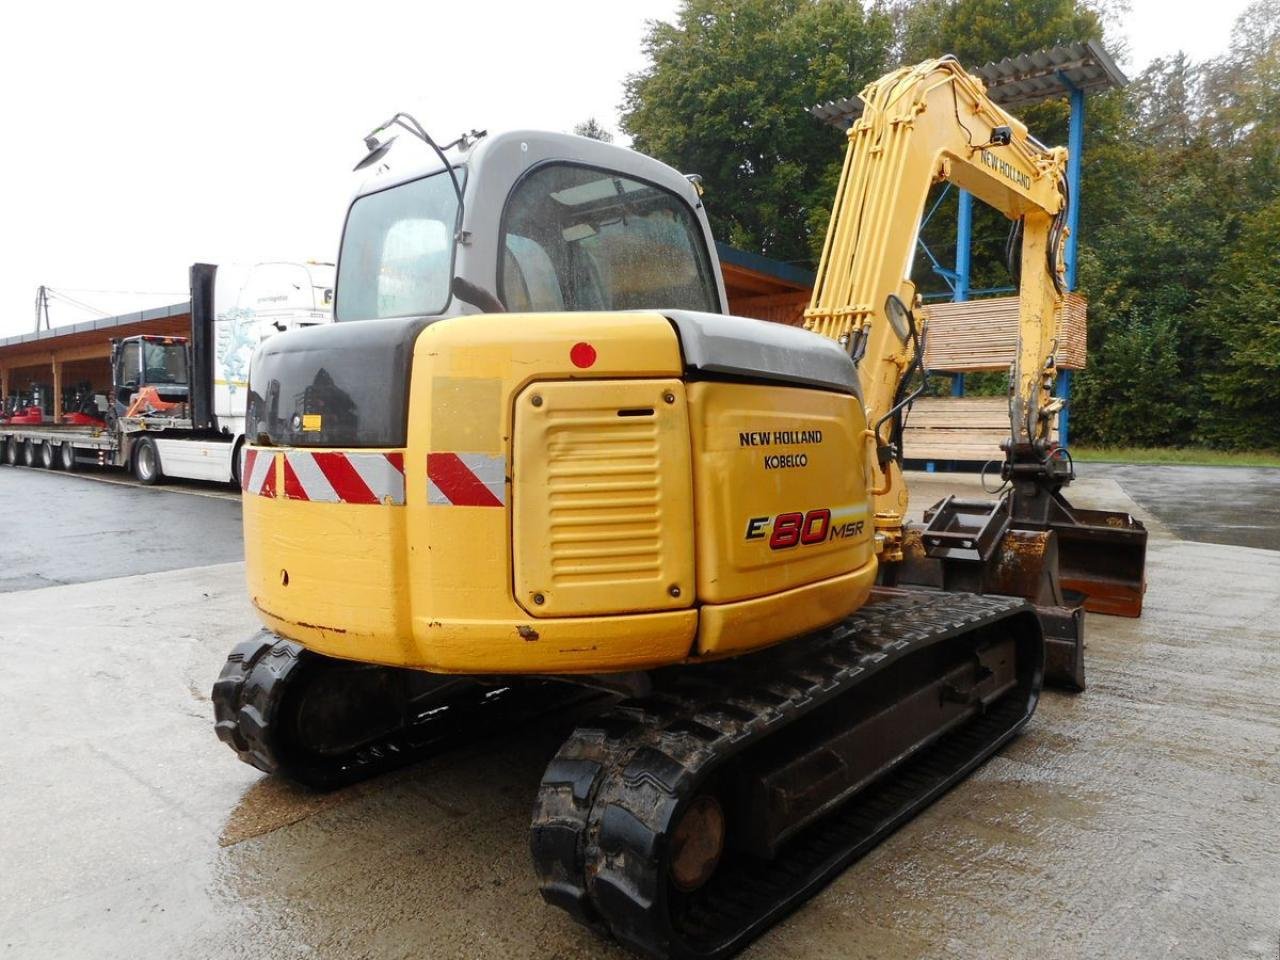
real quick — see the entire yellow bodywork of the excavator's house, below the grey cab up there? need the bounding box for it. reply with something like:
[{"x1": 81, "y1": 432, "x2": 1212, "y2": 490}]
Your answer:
[{"x1": 244, "y1": 314, "x2": 876, "y2": 675}]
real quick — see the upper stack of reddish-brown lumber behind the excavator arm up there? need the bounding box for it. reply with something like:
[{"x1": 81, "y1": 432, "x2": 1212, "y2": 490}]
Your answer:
[{"x1": 924, "y1": 293, "x2": 1087, "y2": 372}]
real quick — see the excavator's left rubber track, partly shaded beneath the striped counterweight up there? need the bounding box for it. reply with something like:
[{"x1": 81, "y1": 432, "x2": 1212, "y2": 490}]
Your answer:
[{"x1": 212, "y1": 630, "x2": 593, "y2": 790}]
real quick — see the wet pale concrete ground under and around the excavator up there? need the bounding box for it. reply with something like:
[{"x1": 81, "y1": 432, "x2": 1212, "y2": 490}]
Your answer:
[{"x1": 0, "y1": 468, "x2": 1280, "y2": 960}]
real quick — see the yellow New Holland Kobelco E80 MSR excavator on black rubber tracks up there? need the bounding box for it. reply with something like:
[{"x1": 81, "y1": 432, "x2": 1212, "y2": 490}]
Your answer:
[{"x1": 214, "y1": 58, "x2": 1140, "y2": 957}]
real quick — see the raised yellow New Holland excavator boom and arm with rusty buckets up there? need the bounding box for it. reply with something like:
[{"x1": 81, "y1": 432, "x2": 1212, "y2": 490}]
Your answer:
[{"x1": 805, "y1": 56, "x2": 1147, "y2": 689}]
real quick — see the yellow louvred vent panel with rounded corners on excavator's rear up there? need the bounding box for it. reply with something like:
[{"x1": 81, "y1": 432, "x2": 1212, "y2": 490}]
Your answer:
[{"x1": 512, "y1": 379, "x2": 694, "y2": 617}]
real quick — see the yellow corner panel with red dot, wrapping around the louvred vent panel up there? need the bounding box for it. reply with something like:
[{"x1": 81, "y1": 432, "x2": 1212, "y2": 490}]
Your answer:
[{"x1": 403, "y1": 312, "x2": 696, "y2": 673}]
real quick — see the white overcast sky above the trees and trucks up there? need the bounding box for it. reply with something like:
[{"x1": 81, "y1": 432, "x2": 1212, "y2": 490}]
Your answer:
[{"x1": 0, "y1": 0, "x2": 1247, "y2": 337}]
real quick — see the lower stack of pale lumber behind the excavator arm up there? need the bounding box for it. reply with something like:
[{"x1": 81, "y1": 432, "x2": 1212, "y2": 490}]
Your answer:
[{"x1": 902, "y1": 397, "x2": 1057, "y2": 463}]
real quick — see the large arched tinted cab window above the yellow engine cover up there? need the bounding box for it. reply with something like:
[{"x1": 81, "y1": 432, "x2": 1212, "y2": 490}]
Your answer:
[{"x1": 498, "y1": 164, "x2": 719, "y2": 311}]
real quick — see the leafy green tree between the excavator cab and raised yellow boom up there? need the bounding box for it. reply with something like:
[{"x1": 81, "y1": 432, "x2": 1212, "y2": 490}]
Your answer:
[{"x1": 622, "y1": 0, "x2": 893, "y2": 266}]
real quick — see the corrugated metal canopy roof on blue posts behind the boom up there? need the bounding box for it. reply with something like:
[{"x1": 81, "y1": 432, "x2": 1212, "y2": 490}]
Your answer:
[{"x1": 809, "y1": 40, "x2": 1129, "y2": 129}]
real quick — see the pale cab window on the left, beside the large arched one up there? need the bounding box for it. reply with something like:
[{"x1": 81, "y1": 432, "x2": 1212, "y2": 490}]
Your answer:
[{"x1": 334, "y1": 170, "x2": 461, "y2": 321}]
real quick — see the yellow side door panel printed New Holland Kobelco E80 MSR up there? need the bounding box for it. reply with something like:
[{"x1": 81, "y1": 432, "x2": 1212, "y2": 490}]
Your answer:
[{"x1": 689, "y1": 381, "x2": 873, "y2": 603}]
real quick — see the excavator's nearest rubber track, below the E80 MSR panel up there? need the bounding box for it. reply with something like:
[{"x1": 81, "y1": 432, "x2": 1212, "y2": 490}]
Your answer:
[{"x1": 530, "y1": 590, "x2": 1043, "y2": 957}]
